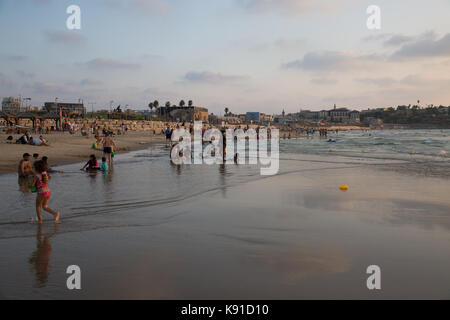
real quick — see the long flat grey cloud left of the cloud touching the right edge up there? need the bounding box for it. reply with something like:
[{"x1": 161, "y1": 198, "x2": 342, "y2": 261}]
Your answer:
[{"x1": 282, "y1": 51, "x2": 384, "y2": 71}]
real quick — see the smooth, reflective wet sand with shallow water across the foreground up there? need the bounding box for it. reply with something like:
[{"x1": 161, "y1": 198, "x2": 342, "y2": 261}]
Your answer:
[{"x1": 0, "y1": 144, "x2": 450, "y2": 299}]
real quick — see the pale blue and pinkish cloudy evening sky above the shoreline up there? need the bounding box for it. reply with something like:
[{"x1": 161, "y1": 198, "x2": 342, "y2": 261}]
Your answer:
[{"x1": 0, "y1": 0, "x2": 450, "y2": 114}]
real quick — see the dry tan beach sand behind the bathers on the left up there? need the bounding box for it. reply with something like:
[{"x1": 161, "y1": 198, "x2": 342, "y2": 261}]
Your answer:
[{"x1": 0, "y1": 131, "x2": 164, "y2": 174}]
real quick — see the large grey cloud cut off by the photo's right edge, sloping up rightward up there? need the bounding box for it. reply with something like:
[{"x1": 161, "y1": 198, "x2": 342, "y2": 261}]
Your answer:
[{"x1": 391, "y1": 32, "x2": 450, "y2": 60}]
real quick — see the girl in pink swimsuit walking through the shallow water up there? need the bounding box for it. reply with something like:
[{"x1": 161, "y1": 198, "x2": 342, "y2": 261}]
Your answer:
[{"x1": 31, "y1": 160, "x2": 60, "y2": 223}]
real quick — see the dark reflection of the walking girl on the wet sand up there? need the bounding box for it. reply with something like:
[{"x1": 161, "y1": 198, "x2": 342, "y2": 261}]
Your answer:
[{"x1": 28, "y1": 224, "x2": 59, "y2": 288}]
